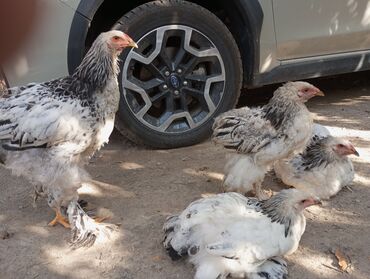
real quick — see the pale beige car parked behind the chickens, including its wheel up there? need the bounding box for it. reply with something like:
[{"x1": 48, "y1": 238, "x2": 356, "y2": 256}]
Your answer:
[{"x1": 3, "y1": 0, "x2": 370, "y2": 148}]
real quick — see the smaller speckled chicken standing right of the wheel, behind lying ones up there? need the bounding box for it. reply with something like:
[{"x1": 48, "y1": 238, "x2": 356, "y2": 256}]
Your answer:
[{"x1": 213, "y1": 82, "x2": 324, "y2": 199}]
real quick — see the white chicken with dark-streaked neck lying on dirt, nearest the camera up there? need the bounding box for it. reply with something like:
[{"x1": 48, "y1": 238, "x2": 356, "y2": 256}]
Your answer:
[{"x1": 163, "y1": 189, "x2": 320, "y2": 279}]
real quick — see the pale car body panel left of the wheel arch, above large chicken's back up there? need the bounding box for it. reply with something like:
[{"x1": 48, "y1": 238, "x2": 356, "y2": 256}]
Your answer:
[{"x1": 3, "y1": 0, "x2": 79, "y2": 87}]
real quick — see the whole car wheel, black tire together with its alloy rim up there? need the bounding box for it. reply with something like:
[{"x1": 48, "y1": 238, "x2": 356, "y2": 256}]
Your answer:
[{"x1": 113, "y1": 0, "x2": 242, "y2": 148}]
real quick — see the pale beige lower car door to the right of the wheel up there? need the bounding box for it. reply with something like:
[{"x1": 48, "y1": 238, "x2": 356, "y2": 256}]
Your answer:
[{"x1": 272, "y1": 0, "x2": 370, "y2": 60}]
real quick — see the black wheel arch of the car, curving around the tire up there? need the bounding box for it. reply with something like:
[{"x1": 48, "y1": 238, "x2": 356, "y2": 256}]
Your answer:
[{"x1": 68, "y1": 0, "x2": 263, "y2": 86}]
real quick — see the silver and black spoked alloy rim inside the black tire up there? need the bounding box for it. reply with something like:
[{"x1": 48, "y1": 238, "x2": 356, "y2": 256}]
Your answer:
[{"x1": 122, "y1": 25, "x2": 225, "y2": 133}]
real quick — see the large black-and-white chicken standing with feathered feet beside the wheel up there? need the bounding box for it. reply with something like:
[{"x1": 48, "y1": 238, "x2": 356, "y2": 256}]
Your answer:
[{"x1": 0, "y1": 31, "x2": 137, "y2": 246}]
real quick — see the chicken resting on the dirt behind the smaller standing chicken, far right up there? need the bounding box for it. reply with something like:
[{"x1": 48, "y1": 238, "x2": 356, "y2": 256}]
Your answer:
[{"x1": 274, "y1": 130, "x2": 359, "y2": 199}]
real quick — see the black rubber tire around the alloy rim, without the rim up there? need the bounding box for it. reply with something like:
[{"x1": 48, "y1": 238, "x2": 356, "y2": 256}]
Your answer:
[{"x1": 114, "y1": 1, "x2": 242, "y2": 148}]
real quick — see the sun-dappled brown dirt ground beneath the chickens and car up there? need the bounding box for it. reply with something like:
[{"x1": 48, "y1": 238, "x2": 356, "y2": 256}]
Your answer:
[{"x1": 0, "y1": 72, "x2": 370, "y2": 279}]
